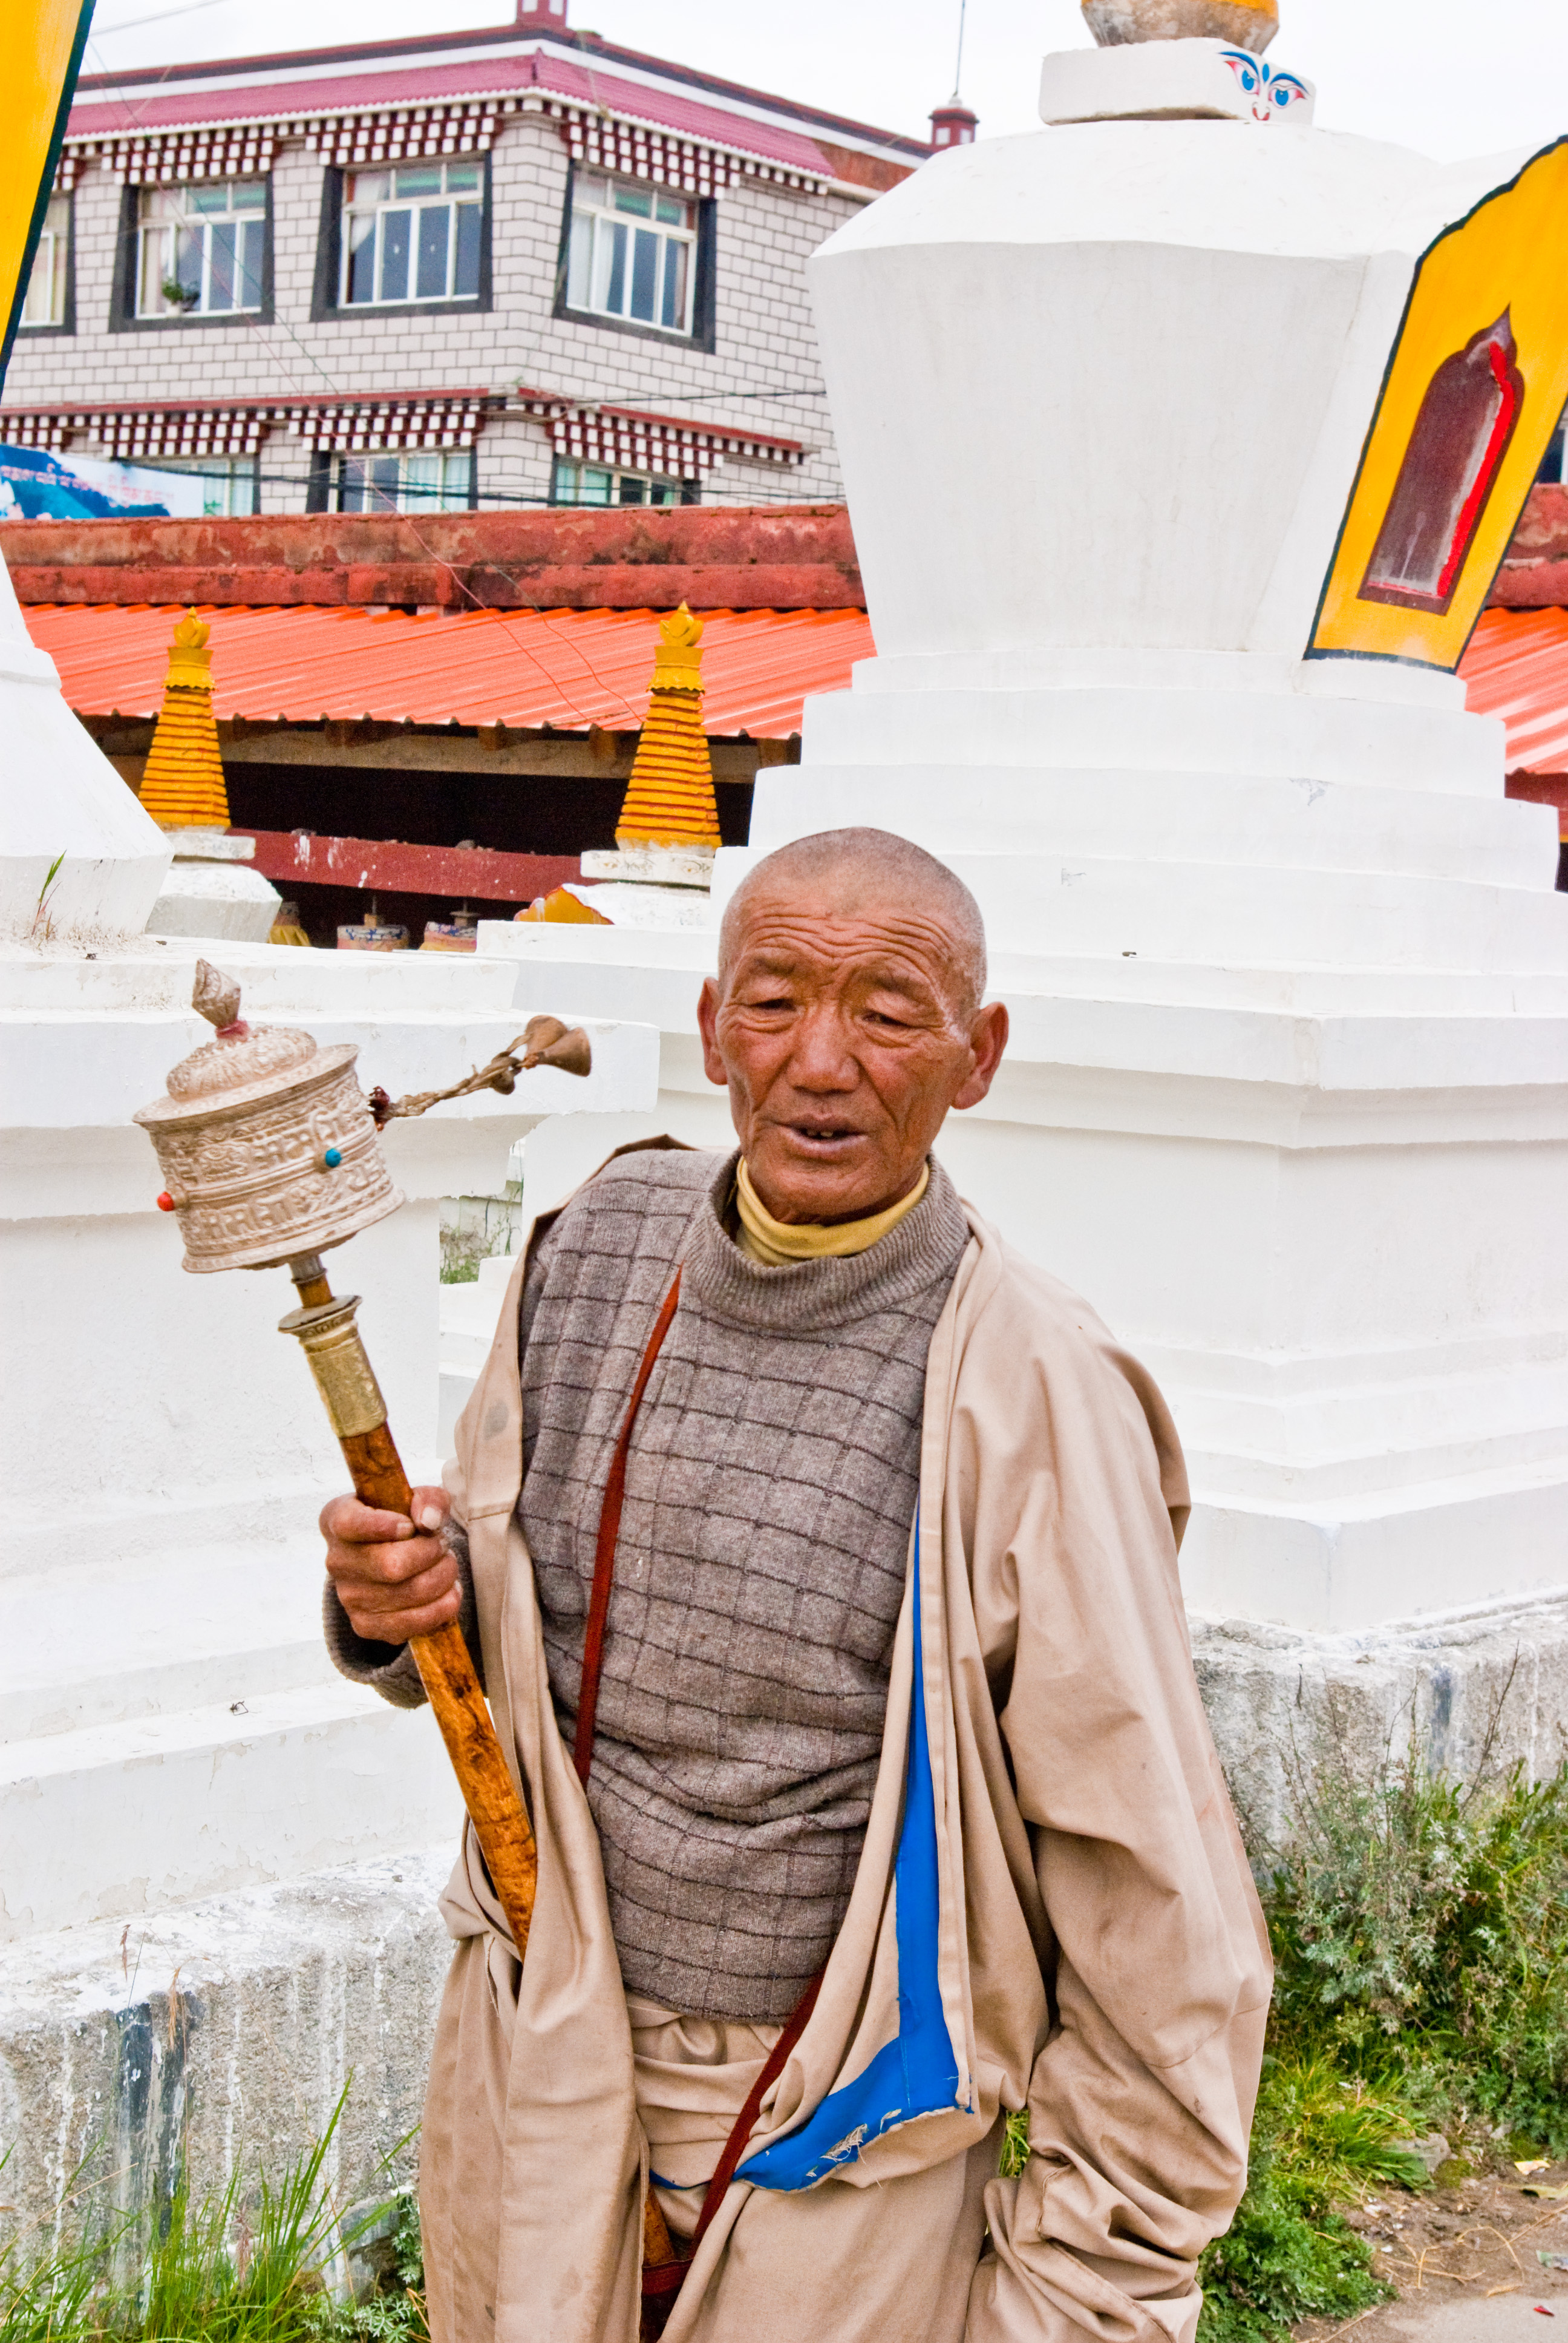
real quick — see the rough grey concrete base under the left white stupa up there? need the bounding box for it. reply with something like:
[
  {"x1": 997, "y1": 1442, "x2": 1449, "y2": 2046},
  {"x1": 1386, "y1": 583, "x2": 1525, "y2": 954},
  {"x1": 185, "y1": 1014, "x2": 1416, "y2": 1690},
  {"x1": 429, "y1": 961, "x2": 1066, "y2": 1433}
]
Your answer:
[{"x1": 0, "y1": 1846, "x2": 455, "y2": 2243}]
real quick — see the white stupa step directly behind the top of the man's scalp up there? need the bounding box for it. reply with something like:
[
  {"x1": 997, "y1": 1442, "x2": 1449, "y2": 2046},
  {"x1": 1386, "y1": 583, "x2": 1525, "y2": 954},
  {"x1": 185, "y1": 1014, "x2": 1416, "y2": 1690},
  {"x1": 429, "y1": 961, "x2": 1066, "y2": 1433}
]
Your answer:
[{"x1": 750, "y1": 764, "x2": 1559, "y2": 888}]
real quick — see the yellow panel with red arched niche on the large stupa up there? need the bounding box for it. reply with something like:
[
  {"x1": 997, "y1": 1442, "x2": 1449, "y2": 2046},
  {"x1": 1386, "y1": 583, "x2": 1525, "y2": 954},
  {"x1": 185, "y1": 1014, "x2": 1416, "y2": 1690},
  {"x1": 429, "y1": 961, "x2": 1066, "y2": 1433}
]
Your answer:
[{"x1": 1308, "y1": 138, "x2": 1568, "y2": 668}]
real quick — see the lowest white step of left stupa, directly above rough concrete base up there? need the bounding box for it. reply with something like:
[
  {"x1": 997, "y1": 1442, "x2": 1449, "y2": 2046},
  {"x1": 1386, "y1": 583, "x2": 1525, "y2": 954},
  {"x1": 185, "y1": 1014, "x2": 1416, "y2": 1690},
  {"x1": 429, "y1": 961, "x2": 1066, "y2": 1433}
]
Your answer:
[{"x1": 0, "y1": 1677, "x2": 462, "y2": 1940}]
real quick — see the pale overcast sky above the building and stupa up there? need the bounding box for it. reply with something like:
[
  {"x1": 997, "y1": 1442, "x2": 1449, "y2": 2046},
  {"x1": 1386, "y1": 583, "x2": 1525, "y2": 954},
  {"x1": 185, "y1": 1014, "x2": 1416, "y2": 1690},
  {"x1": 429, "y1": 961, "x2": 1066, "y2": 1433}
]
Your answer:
[{"x1": 87, "y1": 0, "x2": 1568, "y2": 159}]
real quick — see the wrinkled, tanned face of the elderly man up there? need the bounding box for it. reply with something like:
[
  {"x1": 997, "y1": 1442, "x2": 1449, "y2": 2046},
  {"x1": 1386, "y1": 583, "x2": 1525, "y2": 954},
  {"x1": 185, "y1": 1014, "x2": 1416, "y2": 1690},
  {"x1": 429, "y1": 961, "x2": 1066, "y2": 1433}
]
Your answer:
[{"x1": 699, "y1": 881, "x2": 1008, "y2": 1223}]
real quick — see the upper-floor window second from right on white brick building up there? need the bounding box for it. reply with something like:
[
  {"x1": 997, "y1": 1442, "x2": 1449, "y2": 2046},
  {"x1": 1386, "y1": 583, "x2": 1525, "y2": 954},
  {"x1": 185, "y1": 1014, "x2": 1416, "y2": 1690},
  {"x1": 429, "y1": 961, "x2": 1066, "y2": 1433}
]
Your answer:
[{"x1": 338, "y1": 162, "x2": 485, "y2": 307}]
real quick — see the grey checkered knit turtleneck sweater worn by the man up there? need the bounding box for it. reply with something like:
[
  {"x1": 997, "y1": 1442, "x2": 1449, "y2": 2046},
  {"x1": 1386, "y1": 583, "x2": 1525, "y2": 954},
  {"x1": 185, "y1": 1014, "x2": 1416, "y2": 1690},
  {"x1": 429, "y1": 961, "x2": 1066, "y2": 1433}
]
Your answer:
[{"x1": 328, "y1": 1150, "x2": 968, "y2": 2022}]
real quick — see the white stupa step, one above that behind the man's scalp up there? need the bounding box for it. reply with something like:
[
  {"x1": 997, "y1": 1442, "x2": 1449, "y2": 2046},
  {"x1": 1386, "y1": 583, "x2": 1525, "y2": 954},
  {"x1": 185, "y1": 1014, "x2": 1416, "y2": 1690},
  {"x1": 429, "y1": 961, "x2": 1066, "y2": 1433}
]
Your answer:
[{"x1": 790, "y1": 684, "x2": 1503, "y2": 799}]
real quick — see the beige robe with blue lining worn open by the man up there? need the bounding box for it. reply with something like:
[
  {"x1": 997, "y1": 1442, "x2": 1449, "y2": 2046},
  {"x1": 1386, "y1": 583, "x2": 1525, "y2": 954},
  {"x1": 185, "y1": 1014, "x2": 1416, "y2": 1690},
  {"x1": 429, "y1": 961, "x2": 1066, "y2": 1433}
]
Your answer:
[{"x1": 420, "y1": 1167, "x2": 1270, "y2": 2343}]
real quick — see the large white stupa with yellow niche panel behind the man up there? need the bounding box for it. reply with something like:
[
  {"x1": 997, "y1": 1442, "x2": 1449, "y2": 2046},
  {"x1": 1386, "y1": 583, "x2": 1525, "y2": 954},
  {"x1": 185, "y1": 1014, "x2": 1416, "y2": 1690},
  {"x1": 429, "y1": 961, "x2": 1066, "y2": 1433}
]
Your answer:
[{"x1": 480, "y1": 0, "x2": 1568, "y2": 1790}]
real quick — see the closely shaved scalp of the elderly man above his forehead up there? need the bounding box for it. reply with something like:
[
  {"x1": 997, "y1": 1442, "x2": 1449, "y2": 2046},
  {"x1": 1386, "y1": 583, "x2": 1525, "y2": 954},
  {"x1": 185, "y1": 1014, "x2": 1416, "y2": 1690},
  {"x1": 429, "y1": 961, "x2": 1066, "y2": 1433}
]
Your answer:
[{"x1": 719, "y1": 830, "x2": 984, "y2": 1021}]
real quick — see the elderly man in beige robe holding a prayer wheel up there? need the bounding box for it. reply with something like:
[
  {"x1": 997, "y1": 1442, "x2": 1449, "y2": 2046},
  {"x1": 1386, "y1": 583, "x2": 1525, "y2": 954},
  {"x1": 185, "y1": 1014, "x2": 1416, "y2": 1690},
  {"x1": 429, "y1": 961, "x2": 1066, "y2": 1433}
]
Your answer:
[{"x1": 324, "y1": 830, "x2": 1268, "y2": 2343}]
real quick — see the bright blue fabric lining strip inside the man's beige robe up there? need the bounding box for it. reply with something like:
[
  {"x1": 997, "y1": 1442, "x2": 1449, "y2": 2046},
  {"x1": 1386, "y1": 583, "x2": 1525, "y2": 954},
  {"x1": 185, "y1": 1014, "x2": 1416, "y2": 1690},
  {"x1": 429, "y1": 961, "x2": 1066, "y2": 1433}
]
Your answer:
[{"x1": 736, "y1": 1521, "x2": 963, "y2": 2191}]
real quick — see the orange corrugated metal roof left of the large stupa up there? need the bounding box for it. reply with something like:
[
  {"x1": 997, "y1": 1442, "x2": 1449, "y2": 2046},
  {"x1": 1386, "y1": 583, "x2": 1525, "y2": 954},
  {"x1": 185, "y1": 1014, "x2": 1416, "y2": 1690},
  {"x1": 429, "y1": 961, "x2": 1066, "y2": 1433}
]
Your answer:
[{"x1": 24, "y1": 602, "x2": 874, "y2": 741}]
